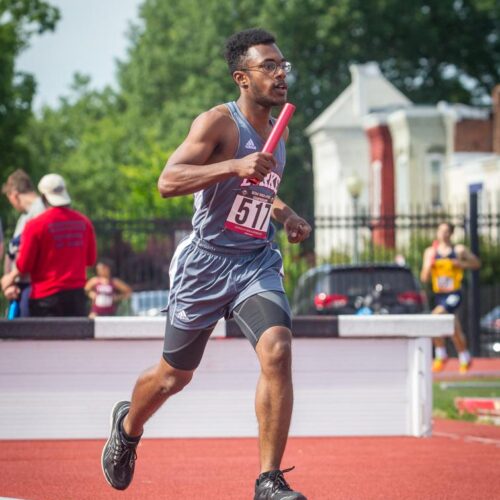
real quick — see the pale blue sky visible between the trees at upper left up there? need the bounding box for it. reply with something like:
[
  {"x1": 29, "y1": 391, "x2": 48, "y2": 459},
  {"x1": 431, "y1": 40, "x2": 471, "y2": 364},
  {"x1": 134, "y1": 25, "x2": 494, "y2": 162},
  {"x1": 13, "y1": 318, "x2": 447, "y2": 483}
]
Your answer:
[{"x1": 17, "y1": 0, "x2": 142, "y2": 109}]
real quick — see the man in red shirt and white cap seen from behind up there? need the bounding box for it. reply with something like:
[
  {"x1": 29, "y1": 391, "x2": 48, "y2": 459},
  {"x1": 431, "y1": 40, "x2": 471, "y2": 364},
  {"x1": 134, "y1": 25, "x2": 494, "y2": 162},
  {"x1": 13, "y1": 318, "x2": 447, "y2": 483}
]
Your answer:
[{"x1": 2, "y1": 174, "x2": 96, "y2": 316}]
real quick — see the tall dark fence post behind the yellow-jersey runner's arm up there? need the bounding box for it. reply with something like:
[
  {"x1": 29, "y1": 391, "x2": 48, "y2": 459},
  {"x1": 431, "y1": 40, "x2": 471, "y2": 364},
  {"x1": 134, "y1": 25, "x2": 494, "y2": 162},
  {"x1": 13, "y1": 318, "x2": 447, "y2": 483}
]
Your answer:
[{"x1": 468, "y1": 184, "x2": 483, "y2": 356}]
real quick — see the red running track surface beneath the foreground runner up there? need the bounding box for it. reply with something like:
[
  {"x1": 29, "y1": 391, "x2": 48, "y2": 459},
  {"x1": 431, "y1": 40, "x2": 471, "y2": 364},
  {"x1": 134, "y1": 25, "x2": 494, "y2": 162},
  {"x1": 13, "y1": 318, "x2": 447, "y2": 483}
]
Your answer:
[{"x1": 0, "y1": 420, "x2": 500, "y2": 500}]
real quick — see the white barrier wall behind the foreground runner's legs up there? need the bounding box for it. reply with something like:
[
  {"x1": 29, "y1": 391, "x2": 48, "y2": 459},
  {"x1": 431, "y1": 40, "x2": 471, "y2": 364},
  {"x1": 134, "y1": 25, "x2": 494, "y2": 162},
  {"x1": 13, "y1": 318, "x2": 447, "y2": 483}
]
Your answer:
[{"x1": 0, "y1": 316, "x2": 453, "y2": 439}]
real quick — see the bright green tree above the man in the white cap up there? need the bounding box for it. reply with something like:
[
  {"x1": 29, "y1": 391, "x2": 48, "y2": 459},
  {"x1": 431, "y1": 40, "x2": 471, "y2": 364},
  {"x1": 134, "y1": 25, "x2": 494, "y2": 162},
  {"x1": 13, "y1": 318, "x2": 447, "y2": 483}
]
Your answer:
[{"x1": 26, "y1": 74, "x2": 191, "y2": 218}]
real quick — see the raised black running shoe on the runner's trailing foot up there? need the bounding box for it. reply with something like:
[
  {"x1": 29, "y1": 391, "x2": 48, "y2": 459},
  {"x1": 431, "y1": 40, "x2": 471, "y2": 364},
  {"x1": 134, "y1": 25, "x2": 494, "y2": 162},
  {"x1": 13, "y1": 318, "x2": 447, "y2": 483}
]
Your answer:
[{"x1": 101, "y1": 401, "x2": 139, "y2": 490}]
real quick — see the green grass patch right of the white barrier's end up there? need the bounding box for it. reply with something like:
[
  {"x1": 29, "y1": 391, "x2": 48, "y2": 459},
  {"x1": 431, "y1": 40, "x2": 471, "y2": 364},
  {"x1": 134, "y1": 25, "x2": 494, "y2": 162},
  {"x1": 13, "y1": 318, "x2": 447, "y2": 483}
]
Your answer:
[{"x1": 433, "y1": 378, "x2": 500, "y2": 422}]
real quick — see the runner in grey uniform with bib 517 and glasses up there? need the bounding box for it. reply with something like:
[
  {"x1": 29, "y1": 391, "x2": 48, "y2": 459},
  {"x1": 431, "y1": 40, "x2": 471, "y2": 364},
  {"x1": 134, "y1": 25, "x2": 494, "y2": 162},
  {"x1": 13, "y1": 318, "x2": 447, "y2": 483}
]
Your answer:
[{"x1": 102, "y1": 29, "x2": 311, "y2": 500}]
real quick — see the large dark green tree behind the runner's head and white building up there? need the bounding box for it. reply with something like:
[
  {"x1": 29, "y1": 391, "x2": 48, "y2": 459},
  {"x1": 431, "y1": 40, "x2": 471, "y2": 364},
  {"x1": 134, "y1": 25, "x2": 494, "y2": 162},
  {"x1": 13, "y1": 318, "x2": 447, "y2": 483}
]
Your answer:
[{"x1": 115, "y1": 0, "x2": 500, "y2": 221}]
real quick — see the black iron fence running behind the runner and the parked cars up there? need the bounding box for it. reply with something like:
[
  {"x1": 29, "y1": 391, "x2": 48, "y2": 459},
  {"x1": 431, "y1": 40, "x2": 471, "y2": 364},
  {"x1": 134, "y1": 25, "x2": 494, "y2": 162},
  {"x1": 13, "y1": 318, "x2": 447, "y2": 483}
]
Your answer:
[{"x1": 3, "y1": 203, "x2": 500, "y2": 355}]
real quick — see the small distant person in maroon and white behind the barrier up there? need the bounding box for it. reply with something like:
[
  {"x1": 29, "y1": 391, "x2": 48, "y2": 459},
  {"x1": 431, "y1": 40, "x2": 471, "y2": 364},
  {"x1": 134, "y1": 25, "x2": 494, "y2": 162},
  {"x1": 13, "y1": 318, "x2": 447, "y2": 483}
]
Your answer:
[{"x1": 85, "y1": 259, "x2": 132, "y2": 318}]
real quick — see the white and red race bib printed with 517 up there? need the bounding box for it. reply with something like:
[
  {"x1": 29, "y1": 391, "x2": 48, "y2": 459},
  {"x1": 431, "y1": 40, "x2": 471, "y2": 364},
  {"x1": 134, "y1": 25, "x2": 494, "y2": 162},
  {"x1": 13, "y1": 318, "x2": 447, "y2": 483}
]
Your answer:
[{"x1": 224, "y1": 189, "x2": 274, "y2": 239}]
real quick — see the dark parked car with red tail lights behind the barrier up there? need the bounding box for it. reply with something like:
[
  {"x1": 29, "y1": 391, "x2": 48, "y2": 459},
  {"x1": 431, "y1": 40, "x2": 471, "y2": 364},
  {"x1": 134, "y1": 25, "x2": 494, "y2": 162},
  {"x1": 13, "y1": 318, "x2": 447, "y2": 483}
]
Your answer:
[{"x1": 292, "y1": 264, "x2": 428, "y2": 315}]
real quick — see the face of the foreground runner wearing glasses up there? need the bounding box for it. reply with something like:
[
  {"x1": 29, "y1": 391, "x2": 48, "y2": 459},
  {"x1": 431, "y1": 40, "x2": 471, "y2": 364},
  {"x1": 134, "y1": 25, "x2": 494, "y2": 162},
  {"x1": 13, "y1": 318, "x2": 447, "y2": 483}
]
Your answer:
[{"x1": 240, "y1": 44, "x2": 288, "y2": 106}]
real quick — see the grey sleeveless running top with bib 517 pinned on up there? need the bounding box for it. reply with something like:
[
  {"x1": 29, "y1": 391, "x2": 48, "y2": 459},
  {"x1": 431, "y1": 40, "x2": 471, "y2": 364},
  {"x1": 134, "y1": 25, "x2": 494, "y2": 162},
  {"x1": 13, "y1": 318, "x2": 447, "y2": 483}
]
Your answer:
[{"x1": 193, "y1": 101, "x2": 286, "y2": 251}]
